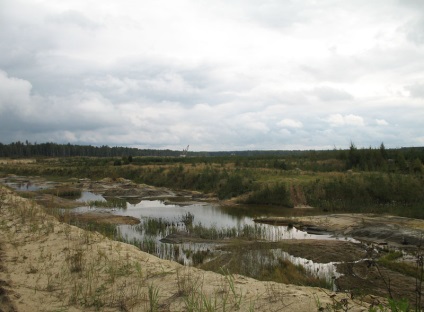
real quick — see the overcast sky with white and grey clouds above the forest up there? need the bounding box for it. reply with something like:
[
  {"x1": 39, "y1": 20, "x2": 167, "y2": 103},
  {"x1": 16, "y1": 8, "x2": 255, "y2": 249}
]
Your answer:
[{"x1": 0, "y1": 0, "x2": 424, "y2": 151}]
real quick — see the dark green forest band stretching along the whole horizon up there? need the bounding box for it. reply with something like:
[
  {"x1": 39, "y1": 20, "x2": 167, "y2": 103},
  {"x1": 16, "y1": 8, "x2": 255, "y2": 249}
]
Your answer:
[{"x1": 0, "y1": 141, "x2": 424, "y2": 172}]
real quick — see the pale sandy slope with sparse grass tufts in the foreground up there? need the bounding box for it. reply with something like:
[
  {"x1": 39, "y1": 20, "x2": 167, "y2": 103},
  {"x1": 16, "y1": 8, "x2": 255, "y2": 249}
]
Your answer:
[{"x1": 0, "y1": 186, "x2": 374, "y2": 311}]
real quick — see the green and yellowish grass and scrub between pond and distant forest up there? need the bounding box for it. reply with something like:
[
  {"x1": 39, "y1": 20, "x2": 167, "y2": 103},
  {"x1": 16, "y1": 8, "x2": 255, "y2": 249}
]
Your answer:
[{"x1": 0, "y1": 143, "x2": 424, "y2": 218}]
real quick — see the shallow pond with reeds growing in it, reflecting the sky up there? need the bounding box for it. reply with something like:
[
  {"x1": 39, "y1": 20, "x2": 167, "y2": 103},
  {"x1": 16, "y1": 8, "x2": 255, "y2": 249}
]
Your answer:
[{"x1": 74, "y1": 192, "x2": 354, "y2": 284}]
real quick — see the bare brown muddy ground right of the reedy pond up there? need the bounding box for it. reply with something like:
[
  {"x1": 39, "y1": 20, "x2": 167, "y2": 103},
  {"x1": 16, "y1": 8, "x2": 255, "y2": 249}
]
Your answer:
[{"x1": 256, "y1": 214, "x2": 424, "y2": 303}]
